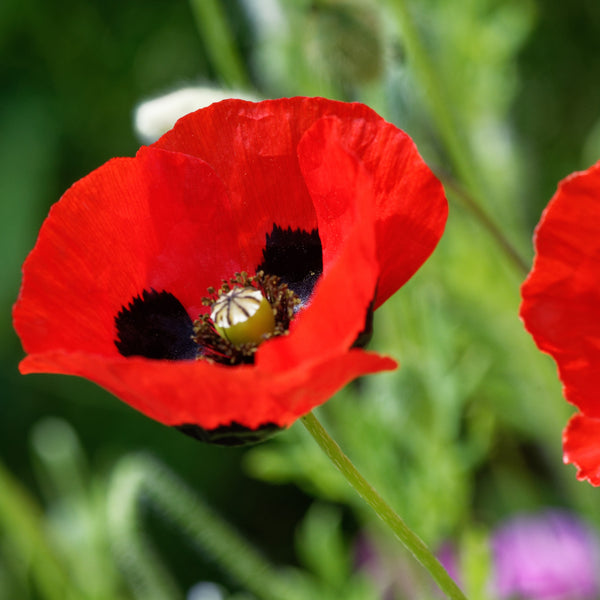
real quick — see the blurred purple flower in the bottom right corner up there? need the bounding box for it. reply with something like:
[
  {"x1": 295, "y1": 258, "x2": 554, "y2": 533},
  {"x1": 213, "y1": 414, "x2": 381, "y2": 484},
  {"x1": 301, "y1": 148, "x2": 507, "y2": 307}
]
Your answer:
[{"x1": 491, "y1": 510, "x2": 600, "y2": 600}]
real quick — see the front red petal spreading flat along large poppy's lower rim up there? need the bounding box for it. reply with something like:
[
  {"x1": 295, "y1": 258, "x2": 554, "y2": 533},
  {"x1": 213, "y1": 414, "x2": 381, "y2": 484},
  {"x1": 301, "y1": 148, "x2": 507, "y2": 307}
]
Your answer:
[{"x1": 20, "y1": 350, "x2": 396, "y2": 429}]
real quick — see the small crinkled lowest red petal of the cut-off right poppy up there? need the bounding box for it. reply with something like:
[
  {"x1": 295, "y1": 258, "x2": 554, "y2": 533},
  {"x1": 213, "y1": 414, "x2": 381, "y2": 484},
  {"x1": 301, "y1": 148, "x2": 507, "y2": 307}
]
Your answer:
[{"x1": 563, "y1": 414, "x2": 600, "y2": 486}]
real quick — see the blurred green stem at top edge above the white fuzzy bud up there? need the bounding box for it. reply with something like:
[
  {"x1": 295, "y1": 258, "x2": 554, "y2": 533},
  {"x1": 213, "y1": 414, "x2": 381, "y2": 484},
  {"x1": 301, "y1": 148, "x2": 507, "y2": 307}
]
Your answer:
[{"x1": 190, "y1": 0, "x2": 250, "y2": 89}]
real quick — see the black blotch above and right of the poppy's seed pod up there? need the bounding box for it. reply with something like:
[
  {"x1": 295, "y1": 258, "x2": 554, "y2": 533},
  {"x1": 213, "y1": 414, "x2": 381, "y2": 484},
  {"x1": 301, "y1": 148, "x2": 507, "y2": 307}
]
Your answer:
[{"x1": 256, "y1": 225, "x2": 323, "y2": 302}]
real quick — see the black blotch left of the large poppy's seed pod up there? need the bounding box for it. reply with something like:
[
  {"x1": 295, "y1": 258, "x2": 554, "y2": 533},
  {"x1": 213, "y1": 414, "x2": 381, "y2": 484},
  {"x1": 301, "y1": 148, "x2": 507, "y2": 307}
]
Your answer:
[{"x1": 115, "y1": 290, "x2": 198, "y2": 360}]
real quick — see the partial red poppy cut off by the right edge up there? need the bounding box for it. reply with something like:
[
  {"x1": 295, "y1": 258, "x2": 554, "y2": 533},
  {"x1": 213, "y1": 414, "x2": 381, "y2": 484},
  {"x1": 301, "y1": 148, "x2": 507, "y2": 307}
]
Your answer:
[{"x1": 521, "y1": 163, "x2": 600, "y2": 485}]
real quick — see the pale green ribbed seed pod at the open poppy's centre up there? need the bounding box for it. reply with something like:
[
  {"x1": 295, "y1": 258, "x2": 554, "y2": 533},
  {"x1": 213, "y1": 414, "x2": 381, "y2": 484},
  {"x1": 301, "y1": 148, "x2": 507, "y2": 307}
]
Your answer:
[{"x1": 210, "y1": 287, "x2": 275, "y2": 346}]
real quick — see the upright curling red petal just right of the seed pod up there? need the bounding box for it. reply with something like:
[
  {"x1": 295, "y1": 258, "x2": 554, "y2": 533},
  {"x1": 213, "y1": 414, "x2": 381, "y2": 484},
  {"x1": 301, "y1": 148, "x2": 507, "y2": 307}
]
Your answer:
[{"x1": 257, "y1": 114, "x2": 379, "y2": 370}]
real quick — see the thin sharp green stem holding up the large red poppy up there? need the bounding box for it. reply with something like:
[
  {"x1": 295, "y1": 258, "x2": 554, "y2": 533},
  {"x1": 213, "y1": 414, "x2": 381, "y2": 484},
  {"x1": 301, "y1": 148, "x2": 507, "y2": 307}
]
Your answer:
[{"x1": 302, "y1": 413, "x2": 467, "y2": 600}]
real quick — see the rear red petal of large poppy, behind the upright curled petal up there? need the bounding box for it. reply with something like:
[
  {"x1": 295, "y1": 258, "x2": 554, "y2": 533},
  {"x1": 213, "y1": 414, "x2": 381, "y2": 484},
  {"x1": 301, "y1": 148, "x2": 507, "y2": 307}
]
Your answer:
[{"x1": 155, "y1": 98, "x2": 448, "y2": 307}]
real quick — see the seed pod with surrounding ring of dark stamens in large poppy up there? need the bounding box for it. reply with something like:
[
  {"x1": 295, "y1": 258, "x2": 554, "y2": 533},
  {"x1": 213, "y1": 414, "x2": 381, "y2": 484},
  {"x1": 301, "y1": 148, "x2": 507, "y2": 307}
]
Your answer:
[{"x1": 192, "y1": 271, "x2": 300, "y2": 365}]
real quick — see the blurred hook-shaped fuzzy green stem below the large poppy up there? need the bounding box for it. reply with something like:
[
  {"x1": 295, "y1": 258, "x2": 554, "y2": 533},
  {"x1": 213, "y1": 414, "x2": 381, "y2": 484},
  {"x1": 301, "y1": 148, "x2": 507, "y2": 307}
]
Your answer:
[{"x1": 109, "y1": 454, "x2": 296, "y2": 600}]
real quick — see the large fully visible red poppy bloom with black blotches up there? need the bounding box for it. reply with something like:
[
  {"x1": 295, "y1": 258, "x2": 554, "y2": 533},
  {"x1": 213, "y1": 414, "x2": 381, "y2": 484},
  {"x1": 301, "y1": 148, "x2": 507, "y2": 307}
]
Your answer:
[{"x1": 14, "y1": 98, "x2": 447, "y2": 443}]
